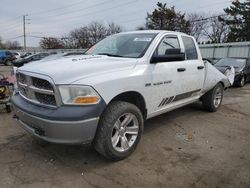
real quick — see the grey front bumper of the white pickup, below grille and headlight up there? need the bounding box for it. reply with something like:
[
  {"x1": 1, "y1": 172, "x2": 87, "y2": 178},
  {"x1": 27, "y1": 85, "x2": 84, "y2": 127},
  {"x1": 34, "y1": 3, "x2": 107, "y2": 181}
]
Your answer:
[{"x1": 12, "y1": 94, "x2": 105, "y2": 144}]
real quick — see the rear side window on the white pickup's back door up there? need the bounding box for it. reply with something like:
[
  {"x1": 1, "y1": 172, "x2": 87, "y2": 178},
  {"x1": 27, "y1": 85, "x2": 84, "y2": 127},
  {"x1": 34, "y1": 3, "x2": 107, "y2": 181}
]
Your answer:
[{"x1": 182, "y1": 36, "x2": 198, "y2": 60}]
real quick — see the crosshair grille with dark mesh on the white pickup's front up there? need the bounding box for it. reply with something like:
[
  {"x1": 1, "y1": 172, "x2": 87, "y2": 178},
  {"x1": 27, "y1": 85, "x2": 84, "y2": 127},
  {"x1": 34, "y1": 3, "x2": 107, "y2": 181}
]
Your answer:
[{"x1": 16, "y1": 73, "x2": 58, "y2": 107}]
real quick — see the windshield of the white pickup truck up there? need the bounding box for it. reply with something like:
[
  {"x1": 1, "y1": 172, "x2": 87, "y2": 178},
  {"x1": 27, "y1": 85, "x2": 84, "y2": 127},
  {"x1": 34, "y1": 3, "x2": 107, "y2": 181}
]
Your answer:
[{"x1": 86, "y1": 33, "x2": 157, "y2": 58}]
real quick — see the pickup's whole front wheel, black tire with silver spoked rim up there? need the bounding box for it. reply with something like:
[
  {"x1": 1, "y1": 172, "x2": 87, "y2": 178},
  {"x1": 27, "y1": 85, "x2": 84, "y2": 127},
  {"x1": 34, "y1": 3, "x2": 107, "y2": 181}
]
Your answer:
[{"x1": 93, "y1": 101, "x2": 144, "y2": 161}]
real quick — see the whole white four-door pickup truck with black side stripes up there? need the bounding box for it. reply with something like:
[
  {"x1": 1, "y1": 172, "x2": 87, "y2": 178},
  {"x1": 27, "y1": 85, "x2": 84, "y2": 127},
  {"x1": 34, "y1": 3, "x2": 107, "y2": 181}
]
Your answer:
[{"x1": 12, "y1": 31, "x2": 230, "y2": 160}]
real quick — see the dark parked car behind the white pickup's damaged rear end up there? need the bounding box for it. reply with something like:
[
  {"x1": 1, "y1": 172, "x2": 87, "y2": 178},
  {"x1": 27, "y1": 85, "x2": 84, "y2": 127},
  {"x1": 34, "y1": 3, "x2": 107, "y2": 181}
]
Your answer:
[{"x1": 214, "y1": 58, "x2": 250, "y2": 87}]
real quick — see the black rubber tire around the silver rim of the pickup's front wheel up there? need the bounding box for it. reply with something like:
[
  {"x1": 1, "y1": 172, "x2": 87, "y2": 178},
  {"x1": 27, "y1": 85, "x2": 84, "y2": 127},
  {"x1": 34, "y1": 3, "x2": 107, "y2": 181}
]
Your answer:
[{"x1": 93, "y1": 101, "x2": 144, "y2": 161}]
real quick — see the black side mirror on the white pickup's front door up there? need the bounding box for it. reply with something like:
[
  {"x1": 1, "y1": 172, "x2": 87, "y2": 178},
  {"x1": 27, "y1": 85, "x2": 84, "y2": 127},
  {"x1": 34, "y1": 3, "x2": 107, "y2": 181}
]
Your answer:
[{"x1": 150, "y1": 48, "x2": 185, "y2": 64}]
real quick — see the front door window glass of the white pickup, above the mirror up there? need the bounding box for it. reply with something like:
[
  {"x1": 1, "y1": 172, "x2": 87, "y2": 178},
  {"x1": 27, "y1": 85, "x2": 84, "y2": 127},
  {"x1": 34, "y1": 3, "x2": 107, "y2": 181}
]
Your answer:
[{"x1": 156, "y1": 36, "x2": 180, "y2": 55}]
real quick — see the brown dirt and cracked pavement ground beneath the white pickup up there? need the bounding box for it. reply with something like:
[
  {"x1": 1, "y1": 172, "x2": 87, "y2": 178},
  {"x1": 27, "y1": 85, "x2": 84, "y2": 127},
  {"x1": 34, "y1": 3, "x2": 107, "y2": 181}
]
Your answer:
[{"x1": 0, "y1": 66, "x2": 250, "y2": 188}]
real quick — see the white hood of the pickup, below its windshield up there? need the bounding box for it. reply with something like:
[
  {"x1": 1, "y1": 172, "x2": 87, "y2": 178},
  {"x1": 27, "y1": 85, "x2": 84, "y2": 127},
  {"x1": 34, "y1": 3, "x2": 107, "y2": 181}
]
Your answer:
[{"x1": 18, "y1": 55, "x2": 137, "y2": 84}]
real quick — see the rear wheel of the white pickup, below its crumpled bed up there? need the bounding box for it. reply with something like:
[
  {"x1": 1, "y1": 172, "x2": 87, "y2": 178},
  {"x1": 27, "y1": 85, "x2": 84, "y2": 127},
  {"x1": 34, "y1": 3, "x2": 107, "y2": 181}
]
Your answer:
[{"x1": 201, "y1": 83, "x2": 224, "y2": 112}]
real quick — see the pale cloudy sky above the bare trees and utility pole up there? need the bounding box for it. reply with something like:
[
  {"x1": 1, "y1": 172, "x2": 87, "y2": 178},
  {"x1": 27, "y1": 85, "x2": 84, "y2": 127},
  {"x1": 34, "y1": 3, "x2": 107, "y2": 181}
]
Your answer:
[{"x1": 0, "y1": 0, "x2": 231, "y2": 47}]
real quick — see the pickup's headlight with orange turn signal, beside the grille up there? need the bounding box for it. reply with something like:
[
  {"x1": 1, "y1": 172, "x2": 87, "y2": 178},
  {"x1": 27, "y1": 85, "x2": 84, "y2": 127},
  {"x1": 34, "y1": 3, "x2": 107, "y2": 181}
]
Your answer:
[{"x1": 59, "y1": 85, "x2": 101, "y2": 105}]
